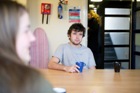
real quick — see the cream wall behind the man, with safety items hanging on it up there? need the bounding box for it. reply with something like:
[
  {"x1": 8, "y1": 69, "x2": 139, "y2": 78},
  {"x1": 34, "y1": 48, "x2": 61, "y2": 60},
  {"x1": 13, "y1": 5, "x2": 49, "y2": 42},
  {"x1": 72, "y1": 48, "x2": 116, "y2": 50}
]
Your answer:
[{"x1": 27, "y1": 0, "x2": 87, "y2": 57}]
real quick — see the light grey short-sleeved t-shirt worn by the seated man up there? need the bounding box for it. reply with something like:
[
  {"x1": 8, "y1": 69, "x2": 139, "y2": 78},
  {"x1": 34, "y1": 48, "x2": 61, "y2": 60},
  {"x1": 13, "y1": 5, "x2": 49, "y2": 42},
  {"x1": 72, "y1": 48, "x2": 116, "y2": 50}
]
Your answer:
[{"x1": 54, "y1": 43, "x2": 96, "y2": 69}]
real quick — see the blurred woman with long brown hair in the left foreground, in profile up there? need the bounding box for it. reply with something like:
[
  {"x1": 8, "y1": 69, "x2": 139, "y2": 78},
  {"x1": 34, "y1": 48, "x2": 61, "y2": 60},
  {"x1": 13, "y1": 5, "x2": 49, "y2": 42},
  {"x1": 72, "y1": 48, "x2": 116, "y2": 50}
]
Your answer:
[{"x1": 0, "y1": 0, "x2": 54, "y2": 93}]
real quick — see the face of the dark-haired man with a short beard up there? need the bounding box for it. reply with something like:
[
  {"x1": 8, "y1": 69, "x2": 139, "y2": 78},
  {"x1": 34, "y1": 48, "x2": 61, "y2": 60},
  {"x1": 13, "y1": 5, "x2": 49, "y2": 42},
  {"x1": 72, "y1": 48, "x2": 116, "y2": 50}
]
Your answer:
[{"x1": 68, "y1": 30, "x2": 83, "y2": 45}]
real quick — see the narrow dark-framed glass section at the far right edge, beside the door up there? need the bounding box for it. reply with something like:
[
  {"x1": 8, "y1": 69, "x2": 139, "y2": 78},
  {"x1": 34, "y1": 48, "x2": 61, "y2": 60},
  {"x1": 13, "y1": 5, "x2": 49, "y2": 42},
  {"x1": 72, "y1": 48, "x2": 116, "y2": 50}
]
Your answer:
[{"x1": 131, "y1": 0, "x2": 140, "y2": 69}]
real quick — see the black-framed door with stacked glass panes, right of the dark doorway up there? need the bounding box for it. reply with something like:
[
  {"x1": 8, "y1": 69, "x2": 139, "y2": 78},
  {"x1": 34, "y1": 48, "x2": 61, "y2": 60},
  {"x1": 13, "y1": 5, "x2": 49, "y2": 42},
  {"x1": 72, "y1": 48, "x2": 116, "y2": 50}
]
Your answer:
[{"x1": 98, "y1": 1, "x2": 131, "y2": 69}]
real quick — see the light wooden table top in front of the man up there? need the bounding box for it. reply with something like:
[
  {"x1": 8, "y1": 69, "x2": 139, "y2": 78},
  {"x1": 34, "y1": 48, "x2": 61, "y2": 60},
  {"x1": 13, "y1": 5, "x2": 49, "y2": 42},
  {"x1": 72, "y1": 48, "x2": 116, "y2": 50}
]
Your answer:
[{"x1": 40, "y1": 69, "x2": 140, "y2": 93}]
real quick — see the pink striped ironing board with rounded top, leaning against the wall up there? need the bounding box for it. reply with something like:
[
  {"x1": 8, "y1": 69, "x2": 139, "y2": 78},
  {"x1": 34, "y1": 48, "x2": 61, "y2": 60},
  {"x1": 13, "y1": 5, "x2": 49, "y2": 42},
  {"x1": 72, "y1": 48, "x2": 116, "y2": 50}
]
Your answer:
[{"x1": 29, "y1": 28, "x2": 49, "y2": 68}]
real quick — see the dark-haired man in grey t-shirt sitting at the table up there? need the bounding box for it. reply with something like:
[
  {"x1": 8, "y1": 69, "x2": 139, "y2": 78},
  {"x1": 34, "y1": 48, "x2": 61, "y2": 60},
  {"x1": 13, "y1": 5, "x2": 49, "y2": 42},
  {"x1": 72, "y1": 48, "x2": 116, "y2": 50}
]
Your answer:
[{"x1": 48, "y1": 23, "x2": 96, "y2": 73}]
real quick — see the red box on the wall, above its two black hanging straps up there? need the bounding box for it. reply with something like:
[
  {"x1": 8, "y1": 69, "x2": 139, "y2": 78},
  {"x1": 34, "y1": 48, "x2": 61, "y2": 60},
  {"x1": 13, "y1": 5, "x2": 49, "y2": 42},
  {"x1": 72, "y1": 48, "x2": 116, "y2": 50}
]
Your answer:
[{"x1": 41, "y1": 3, "x2": 51, "y2": 15}]
